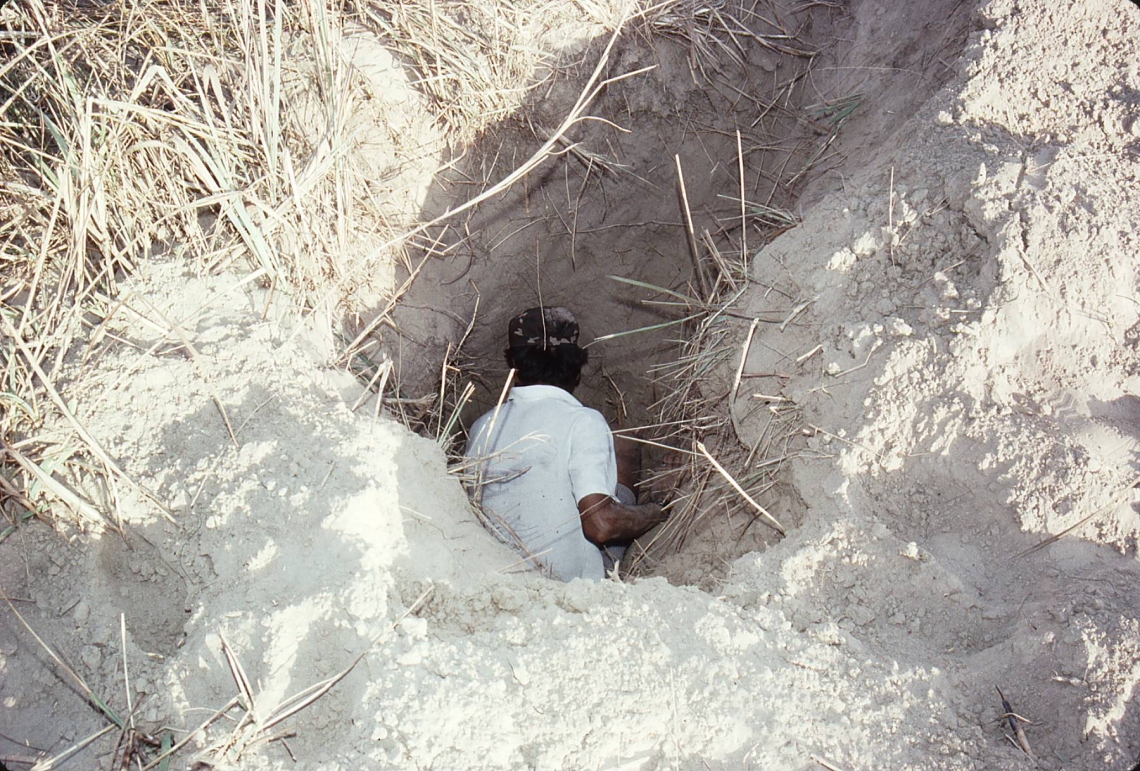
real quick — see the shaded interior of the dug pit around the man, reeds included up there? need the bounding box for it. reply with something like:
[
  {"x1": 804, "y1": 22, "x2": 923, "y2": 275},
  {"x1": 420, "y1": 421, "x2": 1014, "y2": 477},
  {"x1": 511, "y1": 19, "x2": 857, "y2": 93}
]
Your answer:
[{"x1": 365, "y1": 2, "x2": 968, "y2": 579}]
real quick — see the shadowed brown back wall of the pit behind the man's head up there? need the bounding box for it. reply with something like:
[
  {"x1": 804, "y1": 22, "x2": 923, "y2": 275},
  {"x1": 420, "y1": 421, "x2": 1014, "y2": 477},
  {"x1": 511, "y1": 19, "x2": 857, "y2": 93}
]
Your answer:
[{"x1": 383, "y1": 2, "x2": 848, "y2": 427}]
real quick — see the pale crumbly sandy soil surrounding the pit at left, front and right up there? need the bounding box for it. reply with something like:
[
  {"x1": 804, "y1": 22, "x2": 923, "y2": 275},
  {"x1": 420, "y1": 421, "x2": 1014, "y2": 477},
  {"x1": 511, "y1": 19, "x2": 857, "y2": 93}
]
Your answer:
[{"x1": 0, "y1": 0, "x2": 1140, "y2": 770}]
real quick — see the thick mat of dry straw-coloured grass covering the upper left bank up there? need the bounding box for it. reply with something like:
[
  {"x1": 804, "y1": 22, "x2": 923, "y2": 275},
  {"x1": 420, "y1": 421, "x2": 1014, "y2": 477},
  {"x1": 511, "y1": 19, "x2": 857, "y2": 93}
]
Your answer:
[{"x1": 0, "y1": 0, "x2": 633, "y2": 537}]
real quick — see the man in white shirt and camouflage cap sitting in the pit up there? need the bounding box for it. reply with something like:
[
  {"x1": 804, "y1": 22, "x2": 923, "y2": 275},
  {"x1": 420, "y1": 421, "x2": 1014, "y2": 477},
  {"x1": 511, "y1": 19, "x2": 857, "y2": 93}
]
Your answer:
[{"x1": 465, "y1": 307, "x2": 667, "y2": 581}]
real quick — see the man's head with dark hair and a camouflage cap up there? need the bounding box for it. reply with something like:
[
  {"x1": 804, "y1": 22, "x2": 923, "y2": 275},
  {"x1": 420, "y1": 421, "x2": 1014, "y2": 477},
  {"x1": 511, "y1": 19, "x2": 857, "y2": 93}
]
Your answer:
[{"x1": 504, "y1": 307, "x2": 589, "y2": 393}]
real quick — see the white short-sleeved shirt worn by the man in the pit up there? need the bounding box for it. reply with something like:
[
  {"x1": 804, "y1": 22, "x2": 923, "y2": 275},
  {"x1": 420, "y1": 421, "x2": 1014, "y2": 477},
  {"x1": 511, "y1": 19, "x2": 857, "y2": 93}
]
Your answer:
[{"x1": 466, "y1": 386, "x2": 618, "y2": 581}]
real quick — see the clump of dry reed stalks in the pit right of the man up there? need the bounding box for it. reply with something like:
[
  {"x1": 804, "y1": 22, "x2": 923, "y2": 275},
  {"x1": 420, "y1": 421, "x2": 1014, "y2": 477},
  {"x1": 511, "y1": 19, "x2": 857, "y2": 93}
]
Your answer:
[{"x1": 618, "y1": 112, "x2": 820, "y2": 574}]
